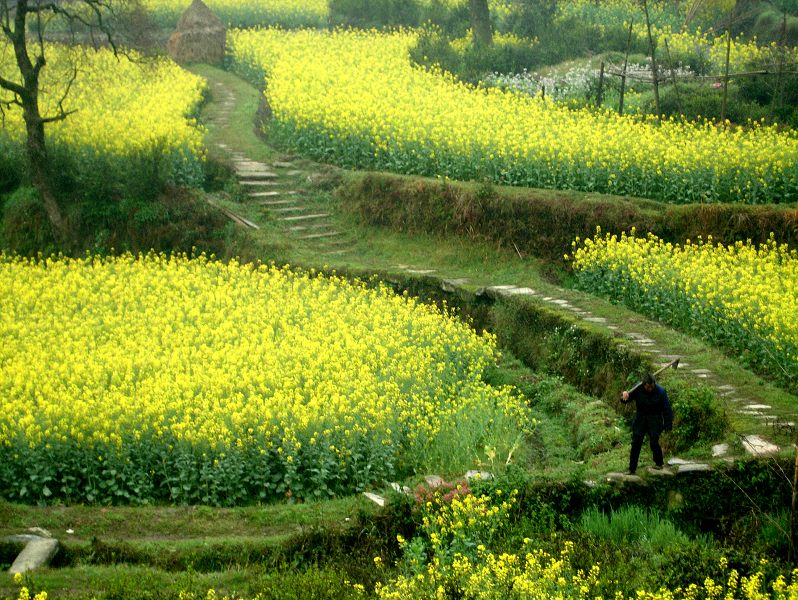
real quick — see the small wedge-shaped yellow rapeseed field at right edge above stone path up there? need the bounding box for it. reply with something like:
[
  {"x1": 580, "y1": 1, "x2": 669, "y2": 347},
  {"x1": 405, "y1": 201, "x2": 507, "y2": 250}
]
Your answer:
[{"x1": 573, "y1": 232, "x2": 798, "y2": 390}]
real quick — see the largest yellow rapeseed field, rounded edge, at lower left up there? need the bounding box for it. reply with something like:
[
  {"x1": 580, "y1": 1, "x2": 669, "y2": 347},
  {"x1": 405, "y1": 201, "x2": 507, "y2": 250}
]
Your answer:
[{"x1": 0, "y1": 255, "x2": 530, "y2": 504}]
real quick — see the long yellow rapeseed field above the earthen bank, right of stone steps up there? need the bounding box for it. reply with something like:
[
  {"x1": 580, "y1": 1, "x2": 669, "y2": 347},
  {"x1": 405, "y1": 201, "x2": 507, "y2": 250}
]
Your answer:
[{"x1": 228, "y1": 29, "x2": 798, "y2": 202}]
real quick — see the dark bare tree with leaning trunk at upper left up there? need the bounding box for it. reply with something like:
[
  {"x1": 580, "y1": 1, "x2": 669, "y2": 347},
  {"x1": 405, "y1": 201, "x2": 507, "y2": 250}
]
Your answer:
[{"x1": 0, "y1": 0, "x2": 116, "y2": 241}]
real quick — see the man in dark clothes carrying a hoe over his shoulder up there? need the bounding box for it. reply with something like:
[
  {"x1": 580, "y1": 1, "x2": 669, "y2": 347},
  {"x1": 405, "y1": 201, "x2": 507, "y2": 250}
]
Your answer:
[{"x1": 621, "y1": 373, "x2": 673, "y2": 475}]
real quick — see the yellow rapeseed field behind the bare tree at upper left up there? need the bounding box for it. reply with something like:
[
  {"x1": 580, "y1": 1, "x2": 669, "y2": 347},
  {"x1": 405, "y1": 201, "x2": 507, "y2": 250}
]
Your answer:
[{"x1": 0, "y1": 45, "x2": 207, "y2": 180}]
